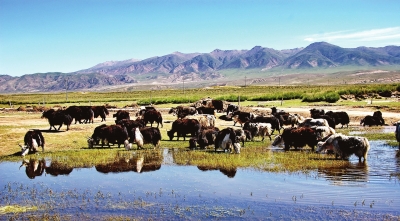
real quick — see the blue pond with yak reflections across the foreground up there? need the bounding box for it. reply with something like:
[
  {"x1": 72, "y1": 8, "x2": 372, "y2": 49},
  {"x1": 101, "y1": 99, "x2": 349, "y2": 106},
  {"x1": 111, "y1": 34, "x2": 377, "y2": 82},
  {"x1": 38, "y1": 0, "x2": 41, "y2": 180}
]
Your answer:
[{"x1": 0, "y1": 141, "x2": 400, "y2": 220}]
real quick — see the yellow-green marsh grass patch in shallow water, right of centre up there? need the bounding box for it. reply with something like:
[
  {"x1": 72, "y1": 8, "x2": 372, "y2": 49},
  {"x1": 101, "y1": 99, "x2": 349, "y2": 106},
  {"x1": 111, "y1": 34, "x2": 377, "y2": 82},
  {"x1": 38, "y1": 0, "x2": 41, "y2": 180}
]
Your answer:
[{"x1": 173, "y1": 146, "x2": 346, "y2": 173}]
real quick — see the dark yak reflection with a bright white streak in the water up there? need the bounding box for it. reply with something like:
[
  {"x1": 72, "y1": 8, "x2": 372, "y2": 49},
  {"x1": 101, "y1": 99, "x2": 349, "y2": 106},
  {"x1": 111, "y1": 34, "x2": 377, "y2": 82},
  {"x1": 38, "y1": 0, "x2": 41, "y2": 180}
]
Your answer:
[{"x1": 95, "y1": 153, "x2": 162, "y2": 173}]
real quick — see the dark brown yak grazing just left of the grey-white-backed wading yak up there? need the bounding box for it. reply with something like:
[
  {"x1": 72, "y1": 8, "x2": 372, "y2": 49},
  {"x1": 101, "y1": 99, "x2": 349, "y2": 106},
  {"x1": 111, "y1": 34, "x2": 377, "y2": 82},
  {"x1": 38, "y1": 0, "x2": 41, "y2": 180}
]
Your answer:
[{"x1": 272, "y1": 127, "x2": 318, "y2": 151}]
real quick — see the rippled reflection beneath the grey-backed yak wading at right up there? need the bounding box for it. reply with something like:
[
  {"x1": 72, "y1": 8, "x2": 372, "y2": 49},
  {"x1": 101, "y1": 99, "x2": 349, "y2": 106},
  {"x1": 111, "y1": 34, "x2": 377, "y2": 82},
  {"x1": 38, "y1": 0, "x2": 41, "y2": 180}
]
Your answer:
[{"x1": 318, "y1": 161, "x2": 368, "y2": 185}]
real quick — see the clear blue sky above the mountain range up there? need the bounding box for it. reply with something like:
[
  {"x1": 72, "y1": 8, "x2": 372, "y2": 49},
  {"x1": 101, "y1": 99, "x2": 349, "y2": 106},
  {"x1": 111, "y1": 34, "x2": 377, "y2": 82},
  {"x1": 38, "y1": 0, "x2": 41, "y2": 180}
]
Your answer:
[{"x1": 0, "y1": 0, "x2": 400, "y2": 76}]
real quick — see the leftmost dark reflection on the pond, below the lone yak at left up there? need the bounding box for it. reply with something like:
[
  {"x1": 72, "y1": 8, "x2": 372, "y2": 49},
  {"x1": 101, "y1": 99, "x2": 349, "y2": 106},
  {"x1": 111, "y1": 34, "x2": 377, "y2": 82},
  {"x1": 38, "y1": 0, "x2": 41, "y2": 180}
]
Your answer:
[{"x1": 19, "y1": 159, "x2": 73, "y2": 179}]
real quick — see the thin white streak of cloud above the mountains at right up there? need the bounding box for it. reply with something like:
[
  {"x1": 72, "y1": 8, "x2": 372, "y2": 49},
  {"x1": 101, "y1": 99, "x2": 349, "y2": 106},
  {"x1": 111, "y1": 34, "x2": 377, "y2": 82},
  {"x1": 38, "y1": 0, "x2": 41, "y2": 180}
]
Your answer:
[{"x1": 304, "y1": 27, "x2": 400, "y2": 42}]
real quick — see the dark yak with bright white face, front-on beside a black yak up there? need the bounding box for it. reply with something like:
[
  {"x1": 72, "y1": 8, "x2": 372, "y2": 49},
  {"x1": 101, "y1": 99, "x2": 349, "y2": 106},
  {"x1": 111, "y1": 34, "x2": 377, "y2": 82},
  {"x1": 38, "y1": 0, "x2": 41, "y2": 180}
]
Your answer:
[{"x1": 130, "y1": 127, "x2": 161, "y2": 149}]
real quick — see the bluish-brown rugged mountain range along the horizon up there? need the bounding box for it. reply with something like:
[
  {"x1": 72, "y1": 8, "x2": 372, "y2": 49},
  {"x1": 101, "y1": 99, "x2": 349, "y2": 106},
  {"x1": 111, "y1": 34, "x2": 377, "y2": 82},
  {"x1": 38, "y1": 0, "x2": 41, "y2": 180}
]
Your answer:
[{"x1": 0, "y1": 42, "x2": 400, "y2": 93}]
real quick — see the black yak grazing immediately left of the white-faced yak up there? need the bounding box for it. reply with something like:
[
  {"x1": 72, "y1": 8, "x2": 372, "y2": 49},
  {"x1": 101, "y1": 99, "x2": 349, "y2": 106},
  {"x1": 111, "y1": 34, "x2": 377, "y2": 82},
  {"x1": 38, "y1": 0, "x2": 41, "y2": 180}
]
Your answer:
[{"x1": 87, "y1": 124, "x2": 132, "y2": 149}]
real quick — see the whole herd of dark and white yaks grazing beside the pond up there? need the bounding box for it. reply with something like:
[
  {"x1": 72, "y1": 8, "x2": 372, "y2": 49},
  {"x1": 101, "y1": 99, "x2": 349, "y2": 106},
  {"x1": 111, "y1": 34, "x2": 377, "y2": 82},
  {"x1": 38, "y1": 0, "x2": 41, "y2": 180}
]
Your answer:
[{"x1": 20, "y1": 99, "x2": 400, "y2": 161}]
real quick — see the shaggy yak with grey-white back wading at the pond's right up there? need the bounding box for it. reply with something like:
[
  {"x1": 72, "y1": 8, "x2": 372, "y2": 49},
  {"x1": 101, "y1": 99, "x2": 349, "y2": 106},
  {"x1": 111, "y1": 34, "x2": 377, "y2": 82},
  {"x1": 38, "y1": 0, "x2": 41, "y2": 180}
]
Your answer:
[{"x1": 317, "y1": 133, "x2": 370, "y2": 162}]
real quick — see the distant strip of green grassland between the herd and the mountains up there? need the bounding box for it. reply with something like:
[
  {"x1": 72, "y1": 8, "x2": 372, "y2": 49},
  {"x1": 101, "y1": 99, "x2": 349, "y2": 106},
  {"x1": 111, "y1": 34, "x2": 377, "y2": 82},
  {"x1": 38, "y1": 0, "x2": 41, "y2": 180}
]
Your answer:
[{"x1": 0, "y1": 84, "x2": 400, "y2": 108}]
